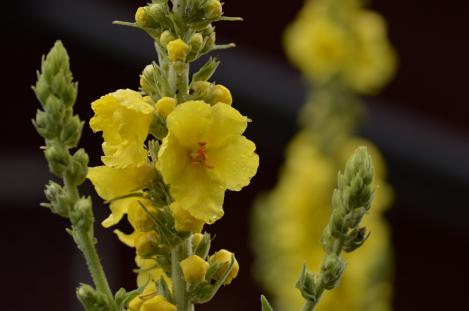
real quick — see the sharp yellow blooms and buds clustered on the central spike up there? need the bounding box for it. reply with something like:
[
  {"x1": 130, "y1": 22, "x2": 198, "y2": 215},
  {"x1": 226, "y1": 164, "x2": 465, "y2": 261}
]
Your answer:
[{"x1": 88, "y1": 80, "x2": 259, "y2": 311}]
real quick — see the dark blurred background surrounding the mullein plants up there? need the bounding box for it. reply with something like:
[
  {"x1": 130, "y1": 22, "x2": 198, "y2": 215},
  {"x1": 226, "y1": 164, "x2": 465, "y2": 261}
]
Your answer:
[{"x1": 0, "y1": 0, "x2": 469, "y2": 311}]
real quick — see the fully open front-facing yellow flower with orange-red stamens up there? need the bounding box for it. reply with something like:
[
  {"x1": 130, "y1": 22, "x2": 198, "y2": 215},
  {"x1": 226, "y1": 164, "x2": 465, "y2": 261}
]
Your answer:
[{"x1": 157, "y1": 101, "x2": 259, "y2": 223}]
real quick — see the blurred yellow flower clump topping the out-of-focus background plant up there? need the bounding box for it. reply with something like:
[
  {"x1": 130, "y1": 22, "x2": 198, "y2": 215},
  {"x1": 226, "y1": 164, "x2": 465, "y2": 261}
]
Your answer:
[{"x1": 284, "y1": 0, "x2": 396, "y2": 94}]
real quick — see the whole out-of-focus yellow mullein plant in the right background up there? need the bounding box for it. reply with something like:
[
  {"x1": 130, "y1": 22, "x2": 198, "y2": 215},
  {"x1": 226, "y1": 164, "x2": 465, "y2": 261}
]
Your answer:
[{"x1": 252, "y1": 0, "x2": 396, "y2": 311}]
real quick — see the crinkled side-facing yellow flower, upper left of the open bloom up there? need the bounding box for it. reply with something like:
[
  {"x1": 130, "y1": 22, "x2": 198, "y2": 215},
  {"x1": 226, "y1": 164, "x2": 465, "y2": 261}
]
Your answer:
[{"x1": 90, "y1": 89, "x2": 154, "y2": 167}]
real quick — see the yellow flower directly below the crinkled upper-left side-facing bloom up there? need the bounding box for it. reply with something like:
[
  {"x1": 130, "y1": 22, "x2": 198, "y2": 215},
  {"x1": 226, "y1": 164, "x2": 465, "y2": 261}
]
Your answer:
[{"x1": 87, "y1": 165, "x2": 155, "y2": 228}]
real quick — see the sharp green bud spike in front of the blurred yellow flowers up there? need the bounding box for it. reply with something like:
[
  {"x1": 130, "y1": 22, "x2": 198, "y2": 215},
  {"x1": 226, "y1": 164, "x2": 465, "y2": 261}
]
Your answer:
[{"x1": 297, "y1": 147, "x2": 374, "y2": 310}]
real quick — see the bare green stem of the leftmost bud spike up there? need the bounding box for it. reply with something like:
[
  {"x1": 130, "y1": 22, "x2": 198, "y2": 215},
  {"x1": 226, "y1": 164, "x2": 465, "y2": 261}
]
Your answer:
[{"x1": 64, "y1": 175, "x2": 119, "y2": 311}]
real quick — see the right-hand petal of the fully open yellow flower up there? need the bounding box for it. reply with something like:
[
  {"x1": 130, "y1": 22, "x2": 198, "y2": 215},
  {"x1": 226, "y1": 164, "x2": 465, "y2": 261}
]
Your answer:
[{"x1": 207, "y1": 136, "x2": 259, "y2": 191}]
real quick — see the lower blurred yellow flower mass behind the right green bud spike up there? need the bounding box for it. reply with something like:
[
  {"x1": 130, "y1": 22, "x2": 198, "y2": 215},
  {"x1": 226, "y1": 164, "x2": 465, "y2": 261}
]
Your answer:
[{"x1": 253, "y1": 131, "x2": 392, "y2": 311}]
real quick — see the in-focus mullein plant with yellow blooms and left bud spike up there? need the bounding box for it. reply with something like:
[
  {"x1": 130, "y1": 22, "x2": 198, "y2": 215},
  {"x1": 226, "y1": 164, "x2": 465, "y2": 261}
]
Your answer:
[{"x1": 33, "y1": 0, "x2": 259, "y2": 311}]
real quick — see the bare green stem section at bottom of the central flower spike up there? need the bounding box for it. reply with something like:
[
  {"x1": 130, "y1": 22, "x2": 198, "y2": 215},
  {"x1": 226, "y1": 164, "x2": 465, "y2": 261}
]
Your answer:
[{"x1": 171, "y1": 237, "x2": 194, "y2": 311}]
